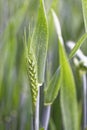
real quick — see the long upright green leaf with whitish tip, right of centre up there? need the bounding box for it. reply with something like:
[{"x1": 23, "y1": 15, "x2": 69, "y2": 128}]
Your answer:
[{"x1": 53, "y1": 12, "x2": 78, "y2": 130}]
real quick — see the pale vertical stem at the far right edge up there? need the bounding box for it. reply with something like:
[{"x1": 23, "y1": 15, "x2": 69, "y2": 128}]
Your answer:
[{"x1": 83, "y1": 74, "x2": 87, "y2": 130}]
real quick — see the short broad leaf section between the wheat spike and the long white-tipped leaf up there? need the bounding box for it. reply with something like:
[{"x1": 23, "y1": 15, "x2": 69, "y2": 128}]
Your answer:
[{"x1": 44, "y1": 68, "x2": 60, "y2": 105}]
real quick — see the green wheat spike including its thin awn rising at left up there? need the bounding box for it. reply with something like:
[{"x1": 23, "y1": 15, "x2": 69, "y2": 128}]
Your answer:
[{"x1": 24, "y1": 29, "x2": 38, "y2": 110}]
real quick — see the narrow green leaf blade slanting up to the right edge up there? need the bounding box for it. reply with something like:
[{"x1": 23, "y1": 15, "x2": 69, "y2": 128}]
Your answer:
[{"x1": 69, "y1": 33, "x2": 87, "y2": 59}]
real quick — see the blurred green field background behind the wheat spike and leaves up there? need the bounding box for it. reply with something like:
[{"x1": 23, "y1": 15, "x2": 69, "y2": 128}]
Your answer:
[{"x1": 0, "y1": 0, "x2": 87, "y2": 130}]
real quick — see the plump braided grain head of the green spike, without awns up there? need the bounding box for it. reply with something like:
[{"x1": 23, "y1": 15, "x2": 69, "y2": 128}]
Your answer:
[{"x1": 27, "y1": 53, "x2": 38, "y2": 108}]
